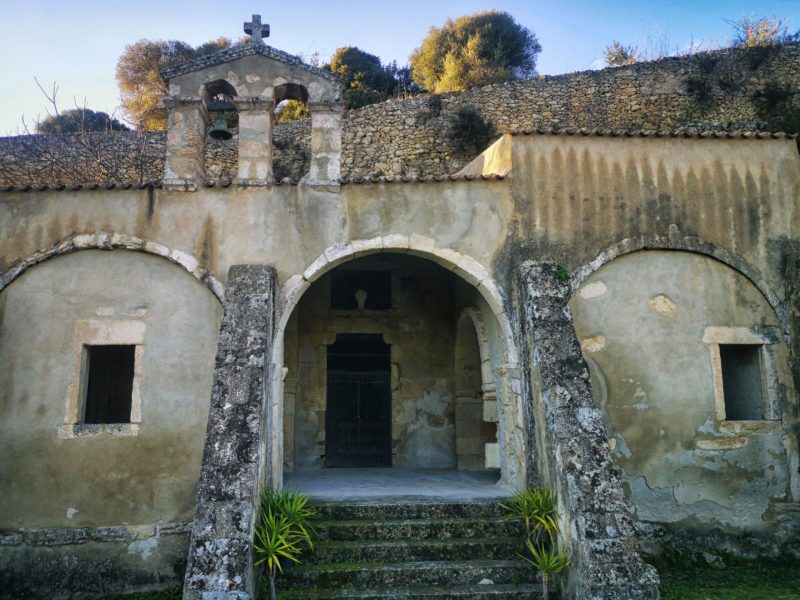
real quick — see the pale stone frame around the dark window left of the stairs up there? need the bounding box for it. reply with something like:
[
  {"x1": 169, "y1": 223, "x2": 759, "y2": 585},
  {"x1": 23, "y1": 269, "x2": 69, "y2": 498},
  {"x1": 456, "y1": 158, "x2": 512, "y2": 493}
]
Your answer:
[{"x1": 58, "y1": 319, "x2": 145, "y2": 439}]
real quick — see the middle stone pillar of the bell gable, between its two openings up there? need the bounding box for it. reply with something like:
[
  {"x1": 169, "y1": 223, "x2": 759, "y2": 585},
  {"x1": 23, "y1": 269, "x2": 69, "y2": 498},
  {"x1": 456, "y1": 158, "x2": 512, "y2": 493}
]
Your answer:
[{"x1": 234, "y1": 96, "x2": 275, "y2": 185}]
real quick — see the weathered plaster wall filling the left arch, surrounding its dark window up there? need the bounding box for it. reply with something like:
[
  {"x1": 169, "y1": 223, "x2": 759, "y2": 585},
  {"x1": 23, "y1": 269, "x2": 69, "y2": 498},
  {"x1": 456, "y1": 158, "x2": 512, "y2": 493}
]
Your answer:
[{"x1": 0, "y1": 250, "x2": 220, "y2": 593}]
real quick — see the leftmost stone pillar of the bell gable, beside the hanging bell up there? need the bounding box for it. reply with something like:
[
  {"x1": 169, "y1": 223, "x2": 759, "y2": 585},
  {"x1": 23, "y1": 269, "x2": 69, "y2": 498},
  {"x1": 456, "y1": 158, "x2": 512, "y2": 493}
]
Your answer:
[{"x1": 162, "y1": 96, "x2": 208, "y2": 191}]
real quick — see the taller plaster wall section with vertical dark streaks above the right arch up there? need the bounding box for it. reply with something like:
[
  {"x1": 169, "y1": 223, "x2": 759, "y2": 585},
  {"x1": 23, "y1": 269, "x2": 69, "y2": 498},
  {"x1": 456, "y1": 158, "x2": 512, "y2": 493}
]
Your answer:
[{"x1": 511, "y1": 135, "x2": 800, "y2": 304}]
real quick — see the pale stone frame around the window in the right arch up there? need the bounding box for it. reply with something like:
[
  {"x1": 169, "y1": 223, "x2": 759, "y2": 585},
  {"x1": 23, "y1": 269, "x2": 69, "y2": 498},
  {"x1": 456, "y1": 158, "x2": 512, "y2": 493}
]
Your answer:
[{"x1": 703, "y1": 326, "x2": 783, "y2": 434}]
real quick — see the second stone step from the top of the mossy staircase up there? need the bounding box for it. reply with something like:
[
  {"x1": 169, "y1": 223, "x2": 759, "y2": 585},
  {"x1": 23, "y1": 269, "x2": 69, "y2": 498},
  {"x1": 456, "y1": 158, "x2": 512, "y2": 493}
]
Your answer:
[{"x1": 314, "y1": 517, "x2": 524, "y2": 541}]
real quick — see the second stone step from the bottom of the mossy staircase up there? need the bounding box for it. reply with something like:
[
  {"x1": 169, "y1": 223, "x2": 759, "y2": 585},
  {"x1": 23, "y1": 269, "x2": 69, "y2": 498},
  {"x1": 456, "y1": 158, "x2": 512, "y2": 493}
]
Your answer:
[{"x1": 284, "y1": 560, "x2": 539, "y2": 590}]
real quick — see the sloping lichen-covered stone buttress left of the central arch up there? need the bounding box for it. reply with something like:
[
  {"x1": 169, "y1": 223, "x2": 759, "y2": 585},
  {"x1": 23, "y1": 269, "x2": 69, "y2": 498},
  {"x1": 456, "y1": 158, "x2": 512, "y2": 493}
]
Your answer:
[{"x1": 183, "y1": 265, "x2": 276, "y2": 600}]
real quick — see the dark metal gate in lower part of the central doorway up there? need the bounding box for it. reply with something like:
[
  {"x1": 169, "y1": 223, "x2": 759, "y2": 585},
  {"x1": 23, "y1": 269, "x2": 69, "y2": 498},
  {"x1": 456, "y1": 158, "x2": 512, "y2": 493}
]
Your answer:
[{"x1": 325, "y1": 370, "x2": 392, "y2": 467}]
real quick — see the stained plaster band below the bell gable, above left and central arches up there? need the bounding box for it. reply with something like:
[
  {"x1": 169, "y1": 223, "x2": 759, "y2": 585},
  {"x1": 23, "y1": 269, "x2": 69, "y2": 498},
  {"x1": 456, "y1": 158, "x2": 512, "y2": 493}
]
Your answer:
[{"x1": 0, "y1": 182, "x2": 512, "y2": 294}]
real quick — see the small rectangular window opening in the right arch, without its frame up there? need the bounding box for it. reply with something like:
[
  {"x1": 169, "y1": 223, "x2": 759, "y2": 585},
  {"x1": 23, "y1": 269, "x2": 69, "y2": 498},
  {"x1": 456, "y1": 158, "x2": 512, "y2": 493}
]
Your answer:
[{"x1": 719, "y1": 344, "x2": 764, "y2": 421}]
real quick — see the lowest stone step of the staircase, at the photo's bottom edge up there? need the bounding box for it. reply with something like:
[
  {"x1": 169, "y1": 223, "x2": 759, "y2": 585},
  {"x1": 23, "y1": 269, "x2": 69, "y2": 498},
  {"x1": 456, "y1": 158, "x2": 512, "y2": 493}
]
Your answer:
[{"x1": 278, "y1": 582, "x2": 542, "y2": 600}]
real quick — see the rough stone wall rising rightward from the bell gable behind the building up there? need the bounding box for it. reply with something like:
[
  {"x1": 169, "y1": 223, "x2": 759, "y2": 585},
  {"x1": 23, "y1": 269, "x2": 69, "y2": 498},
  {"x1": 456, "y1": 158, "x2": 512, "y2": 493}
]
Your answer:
[{"x1": 342, "y1": 44, "x2": 800, "y2": 177}]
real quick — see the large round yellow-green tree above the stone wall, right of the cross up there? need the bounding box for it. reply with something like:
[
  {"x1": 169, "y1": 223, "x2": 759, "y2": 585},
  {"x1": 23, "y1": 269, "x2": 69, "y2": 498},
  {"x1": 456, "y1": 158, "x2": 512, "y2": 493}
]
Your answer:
[{"x1": 410, "y1": 10, "x2": 542, "y2": 93}]
